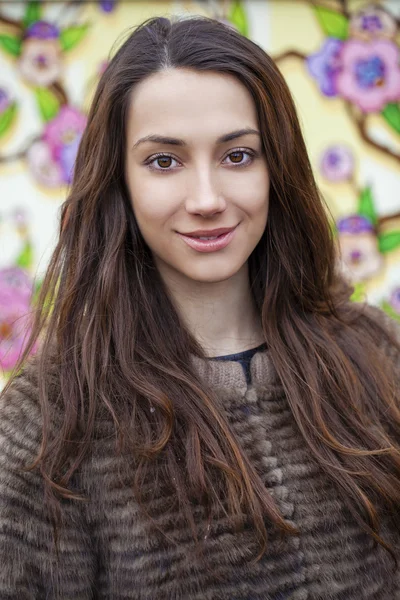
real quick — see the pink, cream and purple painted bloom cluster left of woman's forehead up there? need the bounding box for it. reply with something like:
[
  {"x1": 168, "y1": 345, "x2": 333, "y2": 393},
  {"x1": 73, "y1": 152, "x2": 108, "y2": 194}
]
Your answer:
[{"x1": 27, "y1": 106, "x2": 87, "y2": 187}]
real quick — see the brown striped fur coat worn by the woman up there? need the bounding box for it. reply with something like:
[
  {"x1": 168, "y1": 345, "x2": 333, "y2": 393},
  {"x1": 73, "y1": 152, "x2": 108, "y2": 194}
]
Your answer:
[{"x1": 0, "y1": 308, "x2": 400, "y2": 600}]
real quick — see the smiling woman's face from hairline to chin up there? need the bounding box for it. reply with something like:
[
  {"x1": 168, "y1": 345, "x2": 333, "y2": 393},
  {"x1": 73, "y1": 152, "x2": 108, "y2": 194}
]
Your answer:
[{"x1": 125, "y1": 69, "x2": 269, "y2": 282}]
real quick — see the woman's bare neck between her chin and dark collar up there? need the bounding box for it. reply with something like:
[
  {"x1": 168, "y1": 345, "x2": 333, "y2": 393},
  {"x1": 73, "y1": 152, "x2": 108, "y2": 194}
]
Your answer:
[{"x1": 158, "y1": 264, "x2": 265, "y2": 357}]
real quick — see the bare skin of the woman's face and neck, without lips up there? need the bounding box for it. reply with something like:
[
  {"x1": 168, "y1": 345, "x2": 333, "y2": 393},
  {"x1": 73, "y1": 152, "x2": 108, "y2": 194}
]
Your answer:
[{"x1": 125, "y1": 69, "x2": 269, "y2": 356}]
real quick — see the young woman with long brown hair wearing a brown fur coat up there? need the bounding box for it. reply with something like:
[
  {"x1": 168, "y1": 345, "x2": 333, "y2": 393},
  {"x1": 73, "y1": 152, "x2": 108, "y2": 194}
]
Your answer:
[{"x1": 0, "y1": 18, "x2": 400, "y2": 600}]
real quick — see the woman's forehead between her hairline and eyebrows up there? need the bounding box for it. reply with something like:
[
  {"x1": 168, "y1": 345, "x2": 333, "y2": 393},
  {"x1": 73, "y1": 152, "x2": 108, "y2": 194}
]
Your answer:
[{"x1": 127, "y1": 69, "x2": 257, "y2": 141}]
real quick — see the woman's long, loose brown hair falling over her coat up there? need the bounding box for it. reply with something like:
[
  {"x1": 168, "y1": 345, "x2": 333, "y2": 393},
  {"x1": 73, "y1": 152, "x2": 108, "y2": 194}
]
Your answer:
[{"x1": 4, "y1": 18, "x2": 400, "y2": 550}]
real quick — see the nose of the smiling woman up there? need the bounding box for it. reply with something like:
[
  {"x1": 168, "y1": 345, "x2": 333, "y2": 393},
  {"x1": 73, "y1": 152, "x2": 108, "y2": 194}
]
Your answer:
[{"x1": 186, "y1": 168, "x2": 226, "y2": 217}]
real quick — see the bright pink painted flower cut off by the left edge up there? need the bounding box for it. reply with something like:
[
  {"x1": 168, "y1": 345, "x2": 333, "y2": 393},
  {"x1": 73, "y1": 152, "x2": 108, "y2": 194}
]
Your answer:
[{"x1": 0, "y1": 267, "x2": 32, "y2": 371}]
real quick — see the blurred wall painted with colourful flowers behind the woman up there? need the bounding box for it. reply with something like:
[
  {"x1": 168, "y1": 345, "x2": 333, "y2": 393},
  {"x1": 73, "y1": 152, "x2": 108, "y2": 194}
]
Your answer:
[{"x1": 0, "y1": 0, "x2": 400, "y2": 379}]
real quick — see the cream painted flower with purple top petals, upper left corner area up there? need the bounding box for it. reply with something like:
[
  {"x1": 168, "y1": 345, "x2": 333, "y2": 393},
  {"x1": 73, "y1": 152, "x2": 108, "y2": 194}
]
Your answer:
[{"x1": 19, "y1": 21, "x2": 62, "y2": 87}]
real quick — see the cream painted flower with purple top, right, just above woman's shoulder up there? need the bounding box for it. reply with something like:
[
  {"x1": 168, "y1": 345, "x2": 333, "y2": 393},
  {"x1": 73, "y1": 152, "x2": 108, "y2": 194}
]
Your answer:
[{"x1": 337, "y1": 215, "x2": 382, "y2": 282}]
